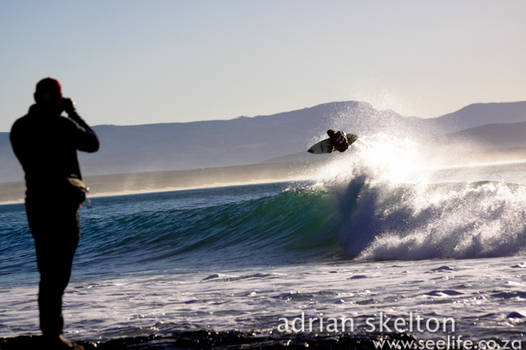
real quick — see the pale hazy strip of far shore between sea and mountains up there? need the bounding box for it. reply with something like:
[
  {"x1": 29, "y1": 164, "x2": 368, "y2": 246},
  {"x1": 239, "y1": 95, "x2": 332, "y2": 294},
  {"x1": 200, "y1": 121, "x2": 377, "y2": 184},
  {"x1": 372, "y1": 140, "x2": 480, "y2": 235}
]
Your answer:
[{"x1": 0, "y1": 149, "x2": 526, "y2": 205}]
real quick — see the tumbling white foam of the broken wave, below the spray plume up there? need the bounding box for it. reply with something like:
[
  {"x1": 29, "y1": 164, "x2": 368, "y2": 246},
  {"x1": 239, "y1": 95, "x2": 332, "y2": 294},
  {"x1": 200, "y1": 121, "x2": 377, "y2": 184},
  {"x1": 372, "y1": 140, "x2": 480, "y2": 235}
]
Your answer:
[{"x1": 344, "y1": 179, "x2": 526, "y2": 260}]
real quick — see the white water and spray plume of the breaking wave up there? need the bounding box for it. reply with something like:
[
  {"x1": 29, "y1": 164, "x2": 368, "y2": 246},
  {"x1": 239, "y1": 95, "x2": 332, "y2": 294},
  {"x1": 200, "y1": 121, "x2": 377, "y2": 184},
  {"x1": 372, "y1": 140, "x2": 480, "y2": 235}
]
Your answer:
[{"x1": 314, "y1": 135, "x2": 526, "y2": 260}]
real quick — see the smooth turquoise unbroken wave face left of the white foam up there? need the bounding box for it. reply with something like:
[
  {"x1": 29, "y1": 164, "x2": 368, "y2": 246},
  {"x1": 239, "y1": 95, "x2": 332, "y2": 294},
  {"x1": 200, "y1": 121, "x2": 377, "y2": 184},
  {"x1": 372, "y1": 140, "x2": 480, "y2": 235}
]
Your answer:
[{"x1": 73, "y1": 185, "x2": 341, "y2": 272}]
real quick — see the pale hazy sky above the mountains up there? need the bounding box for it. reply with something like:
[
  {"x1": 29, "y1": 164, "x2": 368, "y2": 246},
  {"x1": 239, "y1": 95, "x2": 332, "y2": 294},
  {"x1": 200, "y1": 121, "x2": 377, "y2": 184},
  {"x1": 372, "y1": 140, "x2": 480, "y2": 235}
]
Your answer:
[{"x1": 0, "y1": 0, "x2": 526, "y2": 131}]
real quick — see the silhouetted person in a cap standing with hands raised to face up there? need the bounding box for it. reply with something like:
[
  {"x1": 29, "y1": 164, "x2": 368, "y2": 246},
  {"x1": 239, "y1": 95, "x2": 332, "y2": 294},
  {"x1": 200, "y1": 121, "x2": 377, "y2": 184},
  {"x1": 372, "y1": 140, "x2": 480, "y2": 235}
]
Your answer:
[{"x1": 10, "y1": 78, "x2": 99, "y2": 348}]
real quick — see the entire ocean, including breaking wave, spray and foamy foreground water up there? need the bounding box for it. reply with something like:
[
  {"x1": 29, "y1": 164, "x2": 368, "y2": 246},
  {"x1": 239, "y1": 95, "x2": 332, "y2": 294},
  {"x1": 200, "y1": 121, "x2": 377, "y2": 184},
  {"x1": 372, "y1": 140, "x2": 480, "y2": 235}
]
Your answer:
[{"x1": 0, "y1": 139, "x2": 526, "y2": 340}]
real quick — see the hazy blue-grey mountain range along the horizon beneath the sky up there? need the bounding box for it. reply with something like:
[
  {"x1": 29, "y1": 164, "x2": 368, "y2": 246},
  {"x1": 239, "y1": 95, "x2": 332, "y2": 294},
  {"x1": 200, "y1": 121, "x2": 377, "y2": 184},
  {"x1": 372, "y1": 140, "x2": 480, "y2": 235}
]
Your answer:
[{"x1": 0, "y1": 101, "x2": 526, "y2": 181}]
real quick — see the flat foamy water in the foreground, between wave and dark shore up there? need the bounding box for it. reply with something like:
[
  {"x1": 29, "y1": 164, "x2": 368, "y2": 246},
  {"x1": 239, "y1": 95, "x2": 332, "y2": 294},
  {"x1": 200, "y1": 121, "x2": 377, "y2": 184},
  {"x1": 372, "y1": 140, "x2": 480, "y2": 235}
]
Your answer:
[{"x1": 0, "y1": 257, "x2": 526, "y2": 339}]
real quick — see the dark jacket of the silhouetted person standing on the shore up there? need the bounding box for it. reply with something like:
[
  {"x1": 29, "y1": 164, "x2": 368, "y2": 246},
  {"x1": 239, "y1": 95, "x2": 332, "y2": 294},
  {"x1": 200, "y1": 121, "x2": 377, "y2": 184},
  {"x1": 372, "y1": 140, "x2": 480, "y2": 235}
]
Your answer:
[{"x1": 10, "y1": 104, "x2": 99, "y2": 201}]
